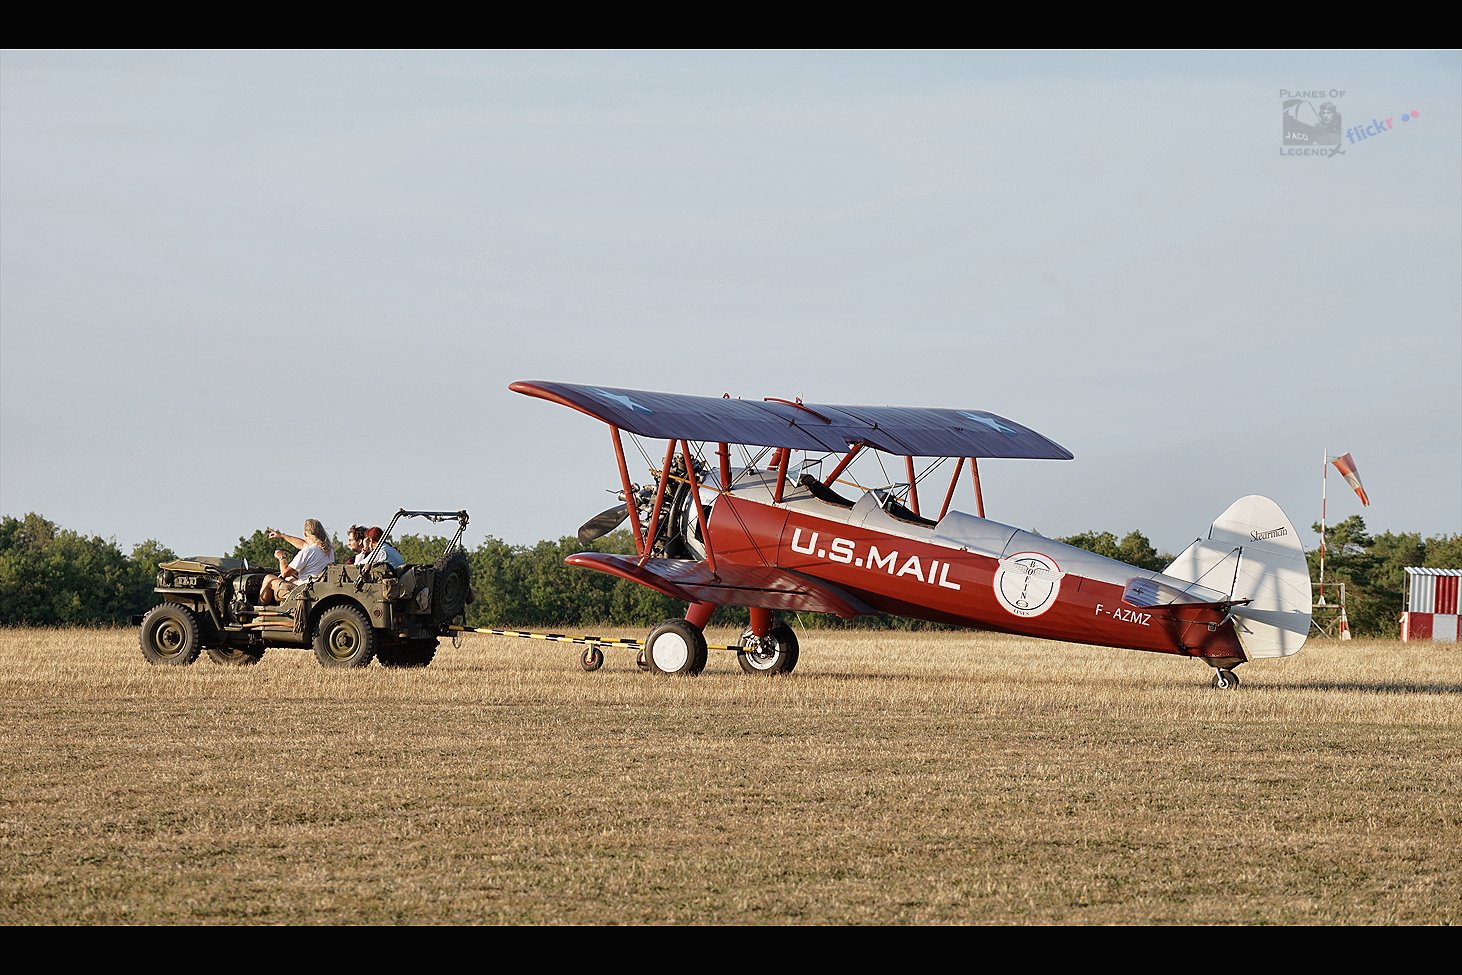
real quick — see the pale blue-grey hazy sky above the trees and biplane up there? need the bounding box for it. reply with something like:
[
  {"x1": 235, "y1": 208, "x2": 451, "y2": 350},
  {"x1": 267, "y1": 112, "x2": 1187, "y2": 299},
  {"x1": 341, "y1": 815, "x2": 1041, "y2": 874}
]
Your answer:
[{"x1": 0, "y1": 51, "x2": 1462, "y2": 555}]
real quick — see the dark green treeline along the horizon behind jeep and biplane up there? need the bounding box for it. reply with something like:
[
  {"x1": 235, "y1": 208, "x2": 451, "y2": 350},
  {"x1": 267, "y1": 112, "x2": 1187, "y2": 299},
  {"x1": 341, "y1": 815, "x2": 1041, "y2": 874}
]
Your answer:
[{"x1": 0, "y1": 513, "x2": 1462, "y2": 636}]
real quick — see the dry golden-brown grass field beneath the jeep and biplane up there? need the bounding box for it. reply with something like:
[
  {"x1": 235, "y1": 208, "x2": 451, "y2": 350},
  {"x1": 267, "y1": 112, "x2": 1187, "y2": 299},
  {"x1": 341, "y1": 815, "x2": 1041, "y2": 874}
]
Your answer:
[{"x1": 0, "y1": 629, "x2": 1462, "y2": 925}]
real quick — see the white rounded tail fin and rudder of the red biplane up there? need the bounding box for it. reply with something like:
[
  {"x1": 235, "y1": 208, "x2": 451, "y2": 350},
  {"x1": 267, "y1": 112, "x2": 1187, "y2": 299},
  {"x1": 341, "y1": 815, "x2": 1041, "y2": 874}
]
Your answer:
[{"x1": 1164, "y1": 494, "x2": 1310, "y2": 659}]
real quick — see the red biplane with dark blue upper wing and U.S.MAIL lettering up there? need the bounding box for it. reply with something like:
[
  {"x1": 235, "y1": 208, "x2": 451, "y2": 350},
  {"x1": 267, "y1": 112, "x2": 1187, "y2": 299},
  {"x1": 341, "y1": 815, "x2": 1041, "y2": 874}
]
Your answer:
[{"x1": 509, "y1": 382, "x2": 1310, "y2": 688}]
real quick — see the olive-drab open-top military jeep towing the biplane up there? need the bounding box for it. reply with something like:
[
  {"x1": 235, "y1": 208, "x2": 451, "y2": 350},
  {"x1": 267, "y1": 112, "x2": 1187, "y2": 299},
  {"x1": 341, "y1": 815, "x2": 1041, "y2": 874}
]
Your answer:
[{"x1": 133, "y1": 509, "x2": 472, "y2": 667}]
